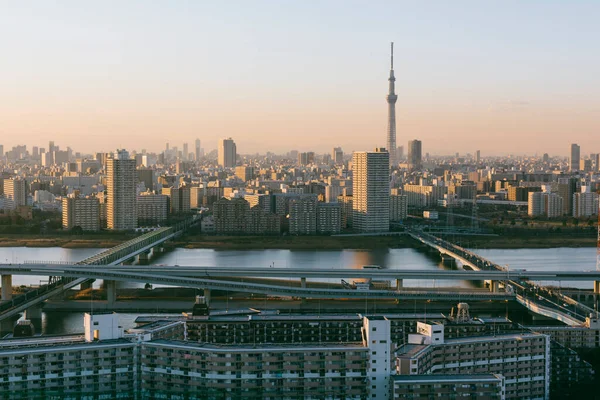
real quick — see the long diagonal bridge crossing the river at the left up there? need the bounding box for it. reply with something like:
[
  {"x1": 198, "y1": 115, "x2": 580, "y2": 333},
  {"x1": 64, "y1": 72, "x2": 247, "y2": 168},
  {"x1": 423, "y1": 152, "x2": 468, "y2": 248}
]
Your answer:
[{"x1": 0, "y1": 216, "x2": 199, "y2": 331}]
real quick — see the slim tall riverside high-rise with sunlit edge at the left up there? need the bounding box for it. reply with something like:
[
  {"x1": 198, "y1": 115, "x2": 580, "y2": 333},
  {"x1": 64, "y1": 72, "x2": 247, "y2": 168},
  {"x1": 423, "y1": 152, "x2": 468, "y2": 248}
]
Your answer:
[{"x1": 106, "y1": 150, "x2": 137, "y2": 230}]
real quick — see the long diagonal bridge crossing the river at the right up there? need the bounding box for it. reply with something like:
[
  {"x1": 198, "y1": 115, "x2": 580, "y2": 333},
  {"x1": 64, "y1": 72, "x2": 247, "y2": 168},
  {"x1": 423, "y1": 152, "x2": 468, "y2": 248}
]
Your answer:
[{"x1": 408, "y1": 230, "x2": 600, "y2": 326}]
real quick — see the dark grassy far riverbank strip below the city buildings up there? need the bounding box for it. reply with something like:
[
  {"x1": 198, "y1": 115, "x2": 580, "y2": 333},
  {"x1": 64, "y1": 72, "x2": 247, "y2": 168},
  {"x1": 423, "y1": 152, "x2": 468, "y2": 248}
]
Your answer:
[{"x1": 0, "y1": 231, "x2": 597, "y2": 250}]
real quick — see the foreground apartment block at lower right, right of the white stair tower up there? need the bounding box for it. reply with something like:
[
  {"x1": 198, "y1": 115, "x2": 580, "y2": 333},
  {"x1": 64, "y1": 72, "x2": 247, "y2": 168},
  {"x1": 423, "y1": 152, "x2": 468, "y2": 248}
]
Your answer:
[{"x1": 396, "y1": 322, "x2": 551, "y2": 399}]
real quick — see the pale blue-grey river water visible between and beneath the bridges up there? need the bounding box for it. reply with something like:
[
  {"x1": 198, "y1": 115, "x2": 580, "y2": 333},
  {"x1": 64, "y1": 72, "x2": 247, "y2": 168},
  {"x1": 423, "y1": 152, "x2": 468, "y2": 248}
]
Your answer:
[{"x1": 0, "y1": 247, "x2": 596, "y2": 334}]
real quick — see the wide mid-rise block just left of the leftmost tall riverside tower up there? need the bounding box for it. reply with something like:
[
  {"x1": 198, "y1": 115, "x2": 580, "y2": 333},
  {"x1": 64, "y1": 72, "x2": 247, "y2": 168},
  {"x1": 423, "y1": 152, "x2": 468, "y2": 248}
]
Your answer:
[{"x1": 62, "y1": 196, "x2": 100, "y2": 231}]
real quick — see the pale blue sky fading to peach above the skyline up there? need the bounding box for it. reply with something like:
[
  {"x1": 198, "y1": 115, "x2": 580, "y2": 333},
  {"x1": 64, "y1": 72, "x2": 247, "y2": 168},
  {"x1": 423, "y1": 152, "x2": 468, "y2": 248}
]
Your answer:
[{"x1": 0, "y1": 0, "x2": 600, "y2": 156}]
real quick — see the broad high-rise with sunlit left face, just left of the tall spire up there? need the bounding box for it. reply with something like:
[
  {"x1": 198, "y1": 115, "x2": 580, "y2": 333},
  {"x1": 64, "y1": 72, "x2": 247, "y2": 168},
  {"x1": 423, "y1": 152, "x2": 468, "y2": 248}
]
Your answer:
[{"x1": 352, "y1": 148, "x2": 390, "y2": 232}]
